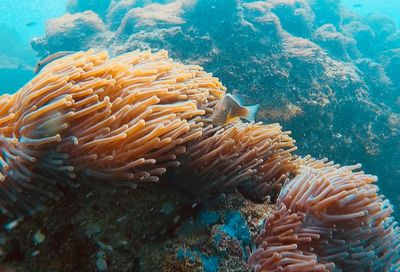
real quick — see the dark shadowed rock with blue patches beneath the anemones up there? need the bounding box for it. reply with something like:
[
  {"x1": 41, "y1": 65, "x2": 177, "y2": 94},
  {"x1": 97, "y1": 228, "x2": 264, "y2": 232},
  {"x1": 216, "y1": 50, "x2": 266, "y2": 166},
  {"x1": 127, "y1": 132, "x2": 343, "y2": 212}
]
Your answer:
[{"x1": 0, "y1": 184, "x2": 273, "y2": 272}]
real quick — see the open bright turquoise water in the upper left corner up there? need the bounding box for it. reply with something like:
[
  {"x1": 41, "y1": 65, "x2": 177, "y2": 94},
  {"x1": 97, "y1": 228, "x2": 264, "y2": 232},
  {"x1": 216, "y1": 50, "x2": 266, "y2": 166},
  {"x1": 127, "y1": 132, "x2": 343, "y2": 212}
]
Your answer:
[{"x1": 0, "y1": 0, "x2": 66, "y2": 93}]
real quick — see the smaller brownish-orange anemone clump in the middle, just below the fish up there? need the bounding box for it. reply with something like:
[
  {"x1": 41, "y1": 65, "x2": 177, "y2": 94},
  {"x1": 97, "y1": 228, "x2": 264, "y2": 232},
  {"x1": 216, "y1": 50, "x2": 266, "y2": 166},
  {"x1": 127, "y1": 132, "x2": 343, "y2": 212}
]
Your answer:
[{"x1": 180, "y1": 122, "x2": 298, "y2": 200}]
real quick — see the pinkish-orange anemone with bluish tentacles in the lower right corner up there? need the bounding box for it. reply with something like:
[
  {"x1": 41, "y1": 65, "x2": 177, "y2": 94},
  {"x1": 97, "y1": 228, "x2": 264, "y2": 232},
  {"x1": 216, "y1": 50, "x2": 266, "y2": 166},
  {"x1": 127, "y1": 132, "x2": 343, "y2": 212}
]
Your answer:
[{"x1": 249, "y1": 157, "x2": 400, "y2": 271}]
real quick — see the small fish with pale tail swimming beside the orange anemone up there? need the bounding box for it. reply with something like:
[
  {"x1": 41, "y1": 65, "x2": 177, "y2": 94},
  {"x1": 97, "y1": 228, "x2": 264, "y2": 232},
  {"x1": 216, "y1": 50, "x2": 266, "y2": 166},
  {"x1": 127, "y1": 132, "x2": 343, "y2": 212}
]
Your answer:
[{"x1": 212, "y1": 94, "x2": 260, "y2": 126}]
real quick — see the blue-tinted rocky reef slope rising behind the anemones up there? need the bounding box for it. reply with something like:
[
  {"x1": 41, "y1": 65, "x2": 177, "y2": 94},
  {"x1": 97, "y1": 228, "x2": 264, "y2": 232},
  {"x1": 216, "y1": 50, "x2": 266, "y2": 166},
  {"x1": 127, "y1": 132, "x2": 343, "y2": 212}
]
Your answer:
[{"x1": 28, "y1": 0, "x2": 400, "y2": 217}]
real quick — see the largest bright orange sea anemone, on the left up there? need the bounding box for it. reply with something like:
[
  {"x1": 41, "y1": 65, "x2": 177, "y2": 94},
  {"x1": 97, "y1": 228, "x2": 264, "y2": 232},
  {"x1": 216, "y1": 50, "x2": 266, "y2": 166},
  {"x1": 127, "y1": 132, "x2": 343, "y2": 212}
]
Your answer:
[{"x1": 0, "y1": 51, "x2": 225, "y2": 217}]
